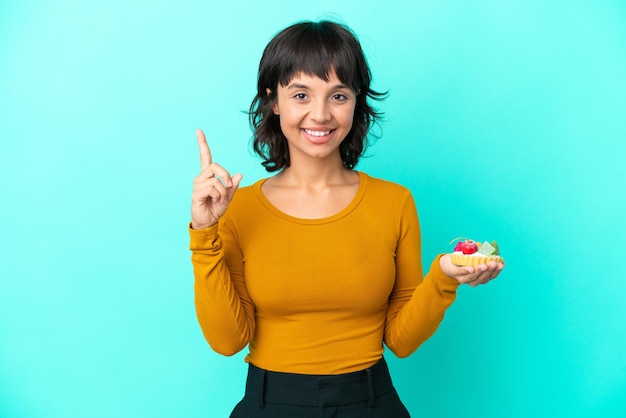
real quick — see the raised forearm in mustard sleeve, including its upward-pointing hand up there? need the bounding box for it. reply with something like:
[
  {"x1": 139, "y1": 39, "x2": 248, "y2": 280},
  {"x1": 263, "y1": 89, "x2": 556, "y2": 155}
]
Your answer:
[{"x1": 189, "y1": 130, "x2": 255, "y2": 355}]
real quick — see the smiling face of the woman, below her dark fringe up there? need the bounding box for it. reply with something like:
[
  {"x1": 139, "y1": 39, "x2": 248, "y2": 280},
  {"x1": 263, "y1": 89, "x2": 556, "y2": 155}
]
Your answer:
[{"x1": 273, "y1": 71, "x2": 356, "y2": 164}]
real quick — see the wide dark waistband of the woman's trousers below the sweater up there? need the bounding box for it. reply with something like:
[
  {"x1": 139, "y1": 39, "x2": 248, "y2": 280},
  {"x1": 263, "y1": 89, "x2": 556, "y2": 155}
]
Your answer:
[{"x1": 246, "y1": 359, "x2": 393, "y2": 407}]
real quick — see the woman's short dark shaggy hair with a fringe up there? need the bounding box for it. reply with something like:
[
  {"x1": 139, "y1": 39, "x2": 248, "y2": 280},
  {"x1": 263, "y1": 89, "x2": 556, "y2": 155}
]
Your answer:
[{"x1": 249, "y1": 21, "x2": 386, "y2": 172}]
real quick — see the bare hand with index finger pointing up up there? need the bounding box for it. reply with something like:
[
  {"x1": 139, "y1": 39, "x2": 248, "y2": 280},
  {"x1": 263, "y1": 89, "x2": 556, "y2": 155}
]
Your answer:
[{"x1": 191, "y1": 129, "x2": 243, "y2": 229}]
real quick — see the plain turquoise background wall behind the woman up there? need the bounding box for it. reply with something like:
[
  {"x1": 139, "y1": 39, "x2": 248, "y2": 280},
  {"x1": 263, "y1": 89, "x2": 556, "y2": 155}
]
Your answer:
[{"x1": 0, "y1": 0, "x2": 626, "y2": 418}]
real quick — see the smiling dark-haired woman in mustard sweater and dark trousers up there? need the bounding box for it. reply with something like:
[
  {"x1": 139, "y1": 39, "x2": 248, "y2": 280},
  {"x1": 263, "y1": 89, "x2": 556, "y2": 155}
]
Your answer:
[{"x1": 189, "y1": 21, "x2": 504, "y2": 418}]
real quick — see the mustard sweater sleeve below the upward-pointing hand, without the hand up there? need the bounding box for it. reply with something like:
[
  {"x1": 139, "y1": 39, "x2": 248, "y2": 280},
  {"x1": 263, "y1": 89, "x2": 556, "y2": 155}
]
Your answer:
[{"x1": 189, "y1": 221, "x2": 255, "y2": 356}]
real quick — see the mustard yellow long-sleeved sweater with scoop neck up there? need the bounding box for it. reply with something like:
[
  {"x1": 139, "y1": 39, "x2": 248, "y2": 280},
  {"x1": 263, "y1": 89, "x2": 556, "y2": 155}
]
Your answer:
[{"x1": 189, "y1": 172, "x2": 458, "y2": 374}]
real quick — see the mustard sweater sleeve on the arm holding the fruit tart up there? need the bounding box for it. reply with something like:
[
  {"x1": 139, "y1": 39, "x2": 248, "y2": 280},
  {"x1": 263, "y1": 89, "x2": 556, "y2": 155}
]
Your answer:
[{"x1": 384, "y1": 193, "x2": 459, "y2": 357}]
